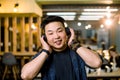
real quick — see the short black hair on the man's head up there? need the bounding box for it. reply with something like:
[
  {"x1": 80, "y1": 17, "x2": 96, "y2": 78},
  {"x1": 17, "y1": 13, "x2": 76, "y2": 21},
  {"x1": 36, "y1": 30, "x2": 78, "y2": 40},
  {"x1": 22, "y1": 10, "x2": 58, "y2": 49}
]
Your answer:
[{"x1": 41, "y1": 16, "x2": 65, "y2": 30}]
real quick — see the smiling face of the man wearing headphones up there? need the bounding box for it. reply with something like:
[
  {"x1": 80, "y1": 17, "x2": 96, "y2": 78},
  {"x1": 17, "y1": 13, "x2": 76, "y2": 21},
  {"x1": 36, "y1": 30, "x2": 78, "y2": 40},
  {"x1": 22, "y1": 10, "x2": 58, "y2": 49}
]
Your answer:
[{"x1": 45, "y1": 22, "x2": 68, "y2": 51}]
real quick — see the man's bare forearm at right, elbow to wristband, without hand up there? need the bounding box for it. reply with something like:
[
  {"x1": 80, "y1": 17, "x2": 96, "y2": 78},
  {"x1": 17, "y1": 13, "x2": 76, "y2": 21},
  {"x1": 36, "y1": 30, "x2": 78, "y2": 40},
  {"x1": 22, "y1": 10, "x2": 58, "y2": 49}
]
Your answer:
[{"x1": 76, "y1": 47, "x2": 102, "y2": 68}]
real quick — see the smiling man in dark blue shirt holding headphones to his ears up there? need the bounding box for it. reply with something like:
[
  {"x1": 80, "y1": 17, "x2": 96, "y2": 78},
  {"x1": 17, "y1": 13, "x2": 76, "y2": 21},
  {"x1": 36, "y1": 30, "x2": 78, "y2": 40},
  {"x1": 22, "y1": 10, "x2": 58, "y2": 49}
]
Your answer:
[{"x1": 21, "y1": 16, "x2": 101, "y2": 80}]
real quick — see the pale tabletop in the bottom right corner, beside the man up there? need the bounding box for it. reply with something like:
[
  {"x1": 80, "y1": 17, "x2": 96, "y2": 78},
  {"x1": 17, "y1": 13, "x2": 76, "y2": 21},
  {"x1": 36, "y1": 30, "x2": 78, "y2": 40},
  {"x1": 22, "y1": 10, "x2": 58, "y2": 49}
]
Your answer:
[{"x1": 87, "y1": 68, "x2": 120, "y2": 80}]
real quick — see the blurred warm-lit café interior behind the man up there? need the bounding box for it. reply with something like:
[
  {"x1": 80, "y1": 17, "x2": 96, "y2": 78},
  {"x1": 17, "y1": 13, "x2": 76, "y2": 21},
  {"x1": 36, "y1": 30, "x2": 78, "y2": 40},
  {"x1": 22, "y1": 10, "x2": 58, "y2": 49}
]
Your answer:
[{"x1": 0, "y1": 0, "x2": 120, "y2": 80}]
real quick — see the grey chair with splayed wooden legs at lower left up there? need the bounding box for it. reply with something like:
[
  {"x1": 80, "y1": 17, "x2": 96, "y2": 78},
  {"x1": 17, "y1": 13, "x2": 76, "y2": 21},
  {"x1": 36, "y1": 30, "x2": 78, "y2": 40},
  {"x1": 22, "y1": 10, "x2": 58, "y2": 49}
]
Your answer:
[{"x1": 2, "y1": 52, "x2": 18, "y2": 80}]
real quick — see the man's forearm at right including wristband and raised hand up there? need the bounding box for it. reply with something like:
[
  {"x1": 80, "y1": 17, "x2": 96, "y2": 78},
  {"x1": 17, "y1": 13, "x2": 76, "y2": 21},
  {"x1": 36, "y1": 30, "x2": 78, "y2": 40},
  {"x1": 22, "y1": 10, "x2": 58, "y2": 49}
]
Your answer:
[{"x1": 68, "y1": 28, "x2": 102, "y2": 68}]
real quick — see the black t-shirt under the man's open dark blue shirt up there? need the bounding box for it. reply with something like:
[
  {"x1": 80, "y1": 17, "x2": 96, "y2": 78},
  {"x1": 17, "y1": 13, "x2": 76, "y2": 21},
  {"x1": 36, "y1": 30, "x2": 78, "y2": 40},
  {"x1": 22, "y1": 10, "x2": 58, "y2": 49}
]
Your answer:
[{"x1": 53, "y1": 48, "x2": 76, "y2": 80}]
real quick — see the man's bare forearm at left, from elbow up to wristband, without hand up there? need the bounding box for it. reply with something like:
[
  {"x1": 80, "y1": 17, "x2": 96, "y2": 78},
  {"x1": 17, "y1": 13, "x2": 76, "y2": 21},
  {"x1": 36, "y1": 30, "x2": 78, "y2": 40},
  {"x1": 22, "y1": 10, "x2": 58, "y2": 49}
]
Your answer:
[{"x1": 21, "y1": 52, "x2": 48, "y2": 80}]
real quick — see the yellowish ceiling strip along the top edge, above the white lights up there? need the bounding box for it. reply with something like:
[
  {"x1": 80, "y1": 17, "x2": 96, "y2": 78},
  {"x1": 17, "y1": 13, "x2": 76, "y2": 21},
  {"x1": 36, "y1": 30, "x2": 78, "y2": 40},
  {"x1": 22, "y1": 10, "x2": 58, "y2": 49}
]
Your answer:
[{"x1": 36, "y1": 0, "x2": 120, "y2": 5}]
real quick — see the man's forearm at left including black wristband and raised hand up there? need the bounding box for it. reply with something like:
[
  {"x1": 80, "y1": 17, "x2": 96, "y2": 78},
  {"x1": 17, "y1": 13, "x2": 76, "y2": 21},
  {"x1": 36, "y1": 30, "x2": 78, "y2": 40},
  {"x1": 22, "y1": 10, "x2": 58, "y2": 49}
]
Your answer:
[{"x1": 21, "y1": 37, "x2": 52, "y2": 80}]
